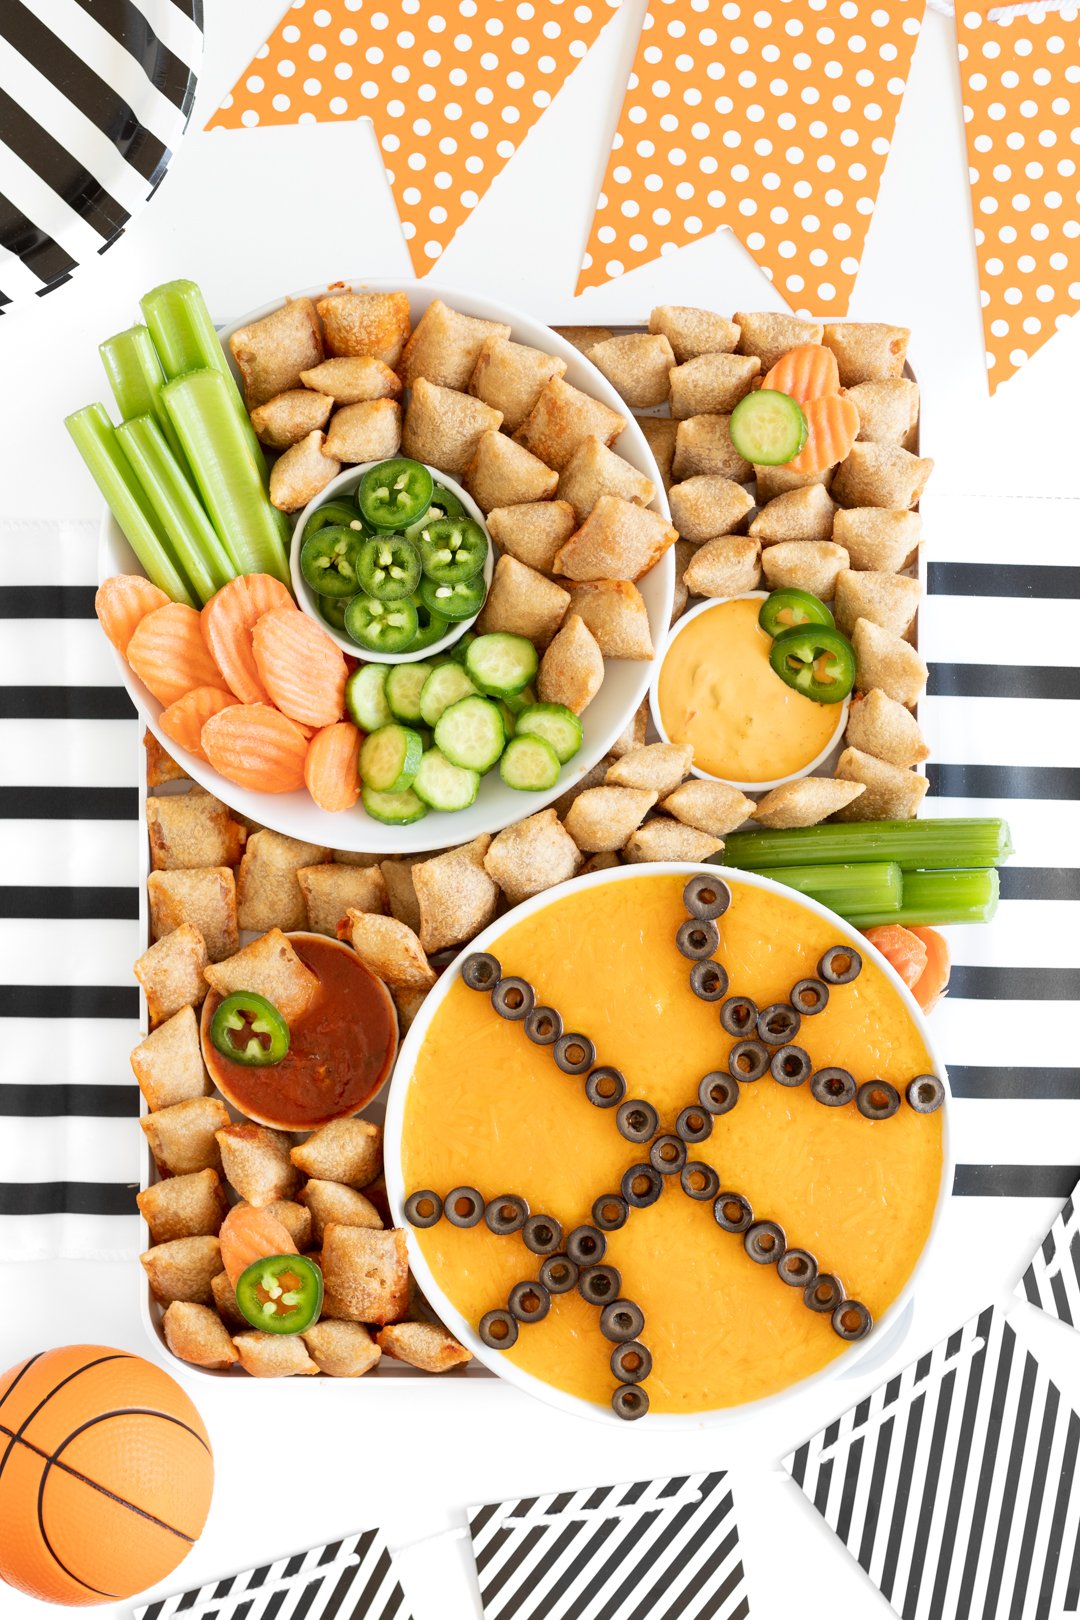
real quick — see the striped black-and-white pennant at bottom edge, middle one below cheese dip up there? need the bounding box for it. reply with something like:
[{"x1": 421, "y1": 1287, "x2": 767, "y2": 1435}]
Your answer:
[{"x1": 470, "y1": 1473, "x2": 750, "y2": 1620}]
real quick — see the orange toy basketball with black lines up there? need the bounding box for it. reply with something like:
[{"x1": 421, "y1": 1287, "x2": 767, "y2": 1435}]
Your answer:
[{"x1": 0, "y1": 1345, "x2": 214, "y2": 1607}]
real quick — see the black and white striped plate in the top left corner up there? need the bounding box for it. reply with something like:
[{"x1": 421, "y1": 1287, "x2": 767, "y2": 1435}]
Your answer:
[{"x1": 0, "y1": 0, "x2": 202, "y2": 313}]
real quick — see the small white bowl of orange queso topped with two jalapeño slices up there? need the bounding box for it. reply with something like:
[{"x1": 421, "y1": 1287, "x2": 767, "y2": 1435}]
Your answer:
[{"x1": 649, "y1": 591, "x2": 848, "y2": 792}]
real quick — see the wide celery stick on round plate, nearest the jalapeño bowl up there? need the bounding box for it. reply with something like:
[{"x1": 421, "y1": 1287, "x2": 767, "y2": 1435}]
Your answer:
[{"x1": 162, "y1": 371, "x2": 288, "y2": 585}]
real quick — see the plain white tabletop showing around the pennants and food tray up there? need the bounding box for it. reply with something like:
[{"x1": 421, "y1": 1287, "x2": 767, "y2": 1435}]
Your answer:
[{"x1": 0, "y1": 0, "x2": 1080, "y2": 1620}]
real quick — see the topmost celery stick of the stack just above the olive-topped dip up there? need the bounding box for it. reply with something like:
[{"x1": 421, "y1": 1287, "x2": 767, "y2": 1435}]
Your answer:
[{"x1": 724, "y1": 816, "x2": 1012, "y2": 872}]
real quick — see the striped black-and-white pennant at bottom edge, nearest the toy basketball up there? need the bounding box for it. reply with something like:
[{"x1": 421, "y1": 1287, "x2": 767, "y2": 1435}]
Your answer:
[{"x1": 134, "y1": 1529, "x2": 410, "y2": 1620}]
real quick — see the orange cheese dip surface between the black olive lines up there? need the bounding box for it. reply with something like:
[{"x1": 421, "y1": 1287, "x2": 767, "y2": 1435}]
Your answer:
[{"x1": 402, "y1": 875, "x2": 942, "y2": 1413}]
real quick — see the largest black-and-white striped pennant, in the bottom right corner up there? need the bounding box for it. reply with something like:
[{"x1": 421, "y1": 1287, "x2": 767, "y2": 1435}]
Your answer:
[{"x1": 784, "y1": 1307, "x2": 1080, "y2": 1620}]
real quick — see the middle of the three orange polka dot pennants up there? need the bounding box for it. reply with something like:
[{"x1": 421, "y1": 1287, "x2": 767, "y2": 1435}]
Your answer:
[{"x1": 578, "y1": 0, "x2": 923, "y2": 316}]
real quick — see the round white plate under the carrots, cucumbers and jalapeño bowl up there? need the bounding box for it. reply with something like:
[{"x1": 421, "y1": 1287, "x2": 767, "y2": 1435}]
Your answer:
[{"x1": 99, "y1": 280, "x2": 675, "y2": 855}]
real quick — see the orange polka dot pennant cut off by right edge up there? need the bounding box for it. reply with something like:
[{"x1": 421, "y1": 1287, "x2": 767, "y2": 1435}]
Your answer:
[{"x1": 957, "y1": 0, "x2": 1080, "y2": 394}]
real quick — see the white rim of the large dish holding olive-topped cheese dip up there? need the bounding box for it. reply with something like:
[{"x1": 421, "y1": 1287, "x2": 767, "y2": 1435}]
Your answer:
[{"x1": 384, "y1": 860, "x2": 954, "y2": 1432}]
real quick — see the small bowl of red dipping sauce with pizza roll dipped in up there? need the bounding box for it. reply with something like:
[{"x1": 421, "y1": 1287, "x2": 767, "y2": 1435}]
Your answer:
[{"x1": 201, "y1": 933, "x2": 398, "y2": 1131}]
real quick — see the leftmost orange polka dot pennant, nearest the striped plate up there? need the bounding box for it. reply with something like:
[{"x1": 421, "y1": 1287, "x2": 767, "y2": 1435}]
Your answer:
[{"x1": 205, "y1": 0, "x2": 620, "y2": 275}]
